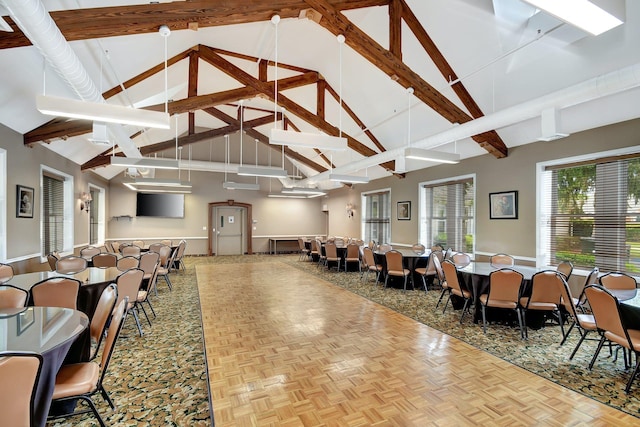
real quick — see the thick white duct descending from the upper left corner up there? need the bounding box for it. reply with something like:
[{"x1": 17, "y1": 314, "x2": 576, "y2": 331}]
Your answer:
[{"x1": 0, "y1": 0, "x2": 142, "y2": 158}]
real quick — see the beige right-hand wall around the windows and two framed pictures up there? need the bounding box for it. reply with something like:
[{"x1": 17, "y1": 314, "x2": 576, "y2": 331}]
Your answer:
[{"x1": 342, "y1": 120, "x2": 640, "y2": 260}]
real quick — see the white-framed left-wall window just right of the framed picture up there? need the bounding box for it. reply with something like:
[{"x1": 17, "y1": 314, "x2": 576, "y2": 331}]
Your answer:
[{"x1": 41, "y1": 166, "x2": 74, "y2": 257}]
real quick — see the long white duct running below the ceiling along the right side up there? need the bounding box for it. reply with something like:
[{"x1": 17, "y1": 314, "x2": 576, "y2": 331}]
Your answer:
[{"x1": 296, "y1": 64, "x2": 640, "y2": 187}]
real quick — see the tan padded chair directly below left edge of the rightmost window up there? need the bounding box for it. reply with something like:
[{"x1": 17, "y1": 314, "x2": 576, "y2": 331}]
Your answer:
[{"x1": 520, "y1": 270, "x2": 565, "y2": 339}]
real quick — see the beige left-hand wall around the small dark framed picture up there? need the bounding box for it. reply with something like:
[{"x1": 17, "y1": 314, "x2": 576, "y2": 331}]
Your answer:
[{"x1": 0, "y1": 125, "x2": 109, "y2": 273}]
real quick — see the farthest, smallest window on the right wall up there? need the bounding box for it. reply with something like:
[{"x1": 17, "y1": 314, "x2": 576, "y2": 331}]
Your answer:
[{"x1": 362, "y1": 190, "x2": 391, "y2": 244}]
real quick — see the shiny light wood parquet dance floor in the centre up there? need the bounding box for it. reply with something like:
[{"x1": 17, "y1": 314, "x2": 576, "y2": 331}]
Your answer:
[{"x1": 197, "y1": 258, "x2": 638, "y2": 427}]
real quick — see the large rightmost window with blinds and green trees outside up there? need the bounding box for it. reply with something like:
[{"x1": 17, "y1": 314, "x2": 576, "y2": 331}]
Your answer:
[{"x1": 539, "y1": 154, "x2": 640, "y2": 274}]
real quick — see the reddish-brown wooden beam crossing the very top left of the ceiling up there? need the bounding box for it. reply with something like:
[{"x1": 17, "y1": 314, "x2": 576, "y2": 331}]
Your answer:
[{"x1": 0, "y1": 0, "x2": 389, "y2": 49}]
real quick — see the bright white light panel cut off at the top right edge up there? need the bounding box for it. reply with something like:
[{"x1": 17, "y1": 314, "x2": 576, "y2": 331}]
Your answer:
[{"x1": 524, "y1": 0, "x2": 622, "y2": 36}]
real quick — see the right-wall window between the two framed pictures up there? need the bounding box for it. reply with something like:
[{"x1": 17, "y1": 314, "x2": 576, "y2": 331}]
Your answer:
[{"x1": 420, "y1": 176, "x2": 475, "y2": 253}]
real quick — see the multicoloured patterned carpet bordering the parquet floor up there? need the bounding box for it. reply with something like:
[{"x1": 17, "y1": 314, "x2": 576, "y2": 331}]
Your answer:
[{"x1": 48, "y1": 255, "x2": 640, "y2": 427}]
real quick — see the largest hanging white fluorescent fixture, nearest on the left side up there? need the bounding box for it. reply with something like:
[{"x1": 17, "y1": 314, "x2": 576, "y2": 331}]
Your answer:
[{"x1": 36, "y1": 95, "x2": 170, "y2": 129}]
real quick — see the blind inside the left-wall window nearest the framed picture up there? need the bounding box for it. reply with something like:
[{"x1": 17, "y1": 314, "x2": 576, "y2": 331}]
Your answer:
[{"x1": 42, "y1": 175, "x2": 64, "y2": 256}]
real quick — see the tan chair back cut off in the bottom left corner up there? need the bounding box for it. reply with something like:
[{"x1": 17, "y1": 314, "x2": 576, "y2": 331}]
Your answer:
[{"x1": 0, "y1": 352, "x2": 42, "y2": 426}]
